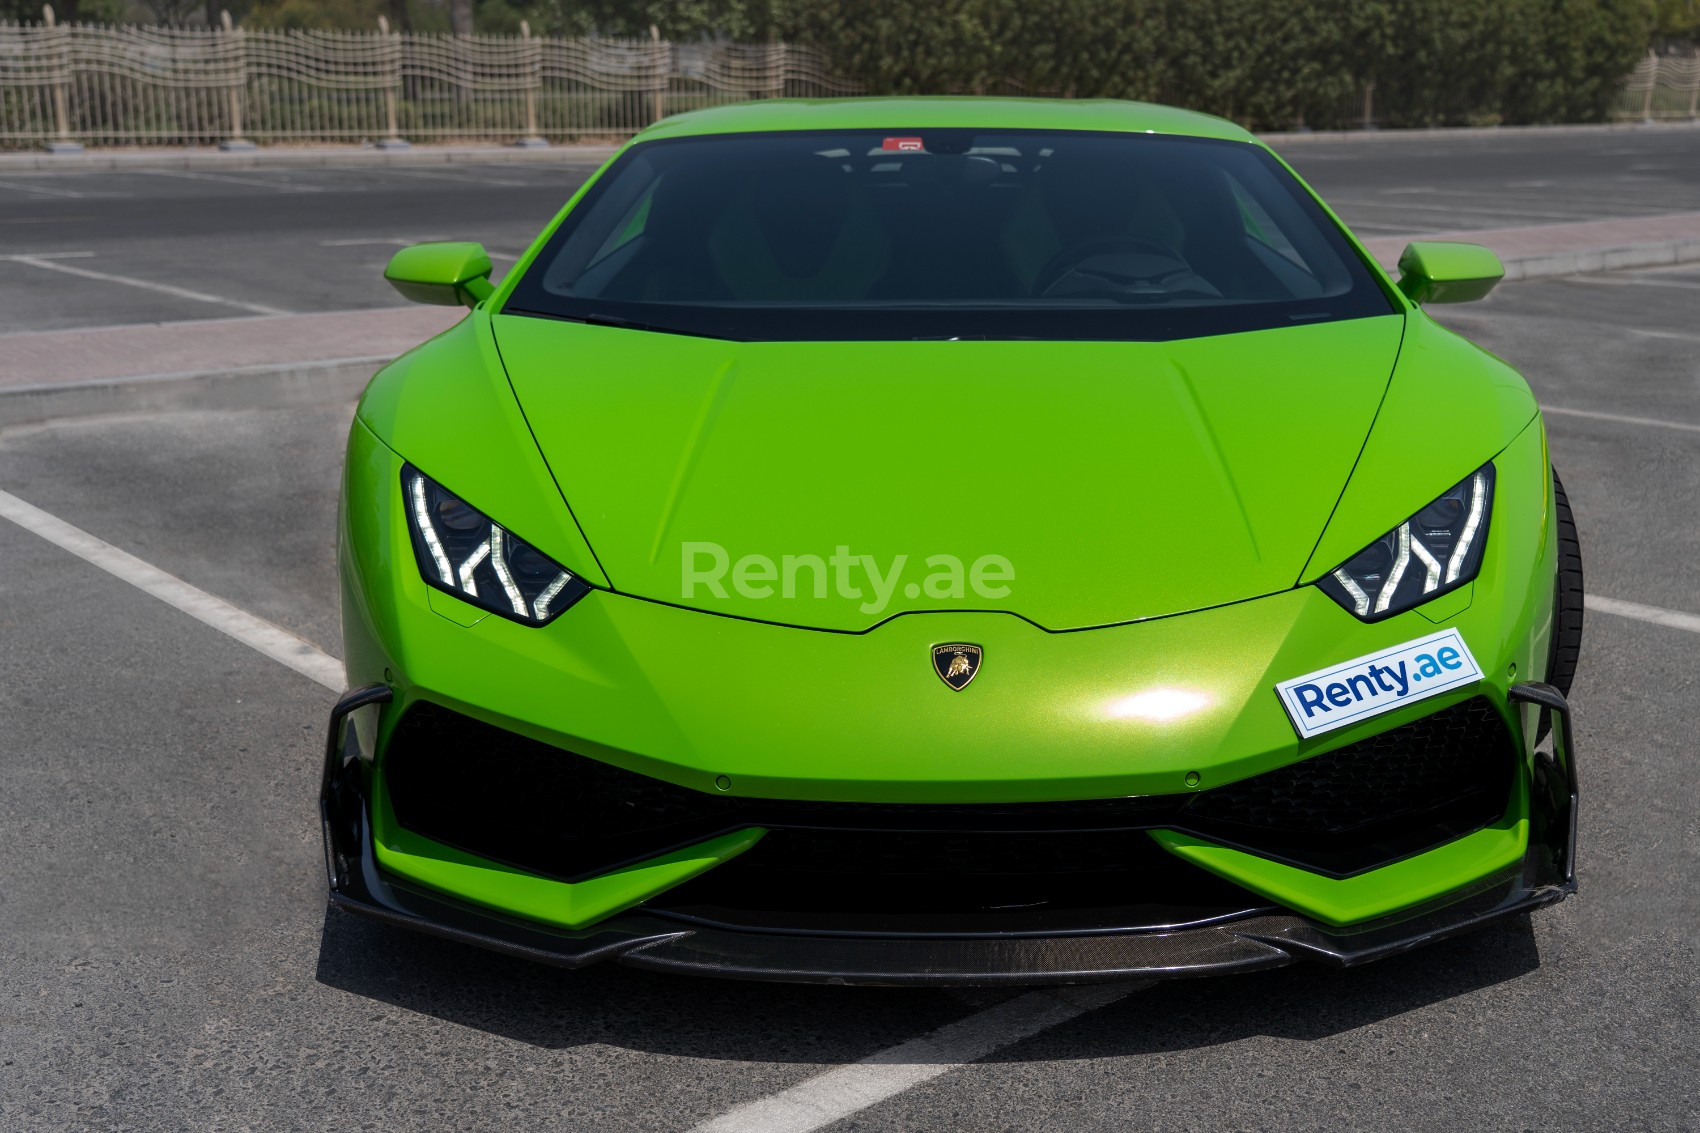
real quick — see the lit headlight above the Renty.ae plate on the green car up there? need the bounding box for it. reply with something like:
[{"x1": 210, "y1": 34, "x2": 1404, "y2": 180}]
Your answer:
[{"x1": 1316, "y1": 464, "x2": 1493, "y2": 621}]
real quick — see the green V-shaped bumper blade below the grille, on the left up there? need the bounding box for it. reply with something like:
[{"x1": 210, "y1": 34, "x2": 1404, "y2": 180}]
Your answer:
[{"x1": 372, "y1": 768, "x2": 767, "y2": 929}]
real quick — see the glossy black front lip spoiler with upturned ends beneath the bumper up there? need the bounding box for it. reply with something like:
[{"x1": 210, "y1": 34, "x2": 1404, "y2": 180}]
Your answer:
[{"x1": 320, "y1": 684, "x2": 1576, "y2": 987}]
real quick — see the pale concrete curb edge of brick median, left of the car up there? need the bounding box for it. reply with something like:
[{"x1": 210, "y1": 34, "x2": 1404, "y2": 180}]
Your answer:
[{"x1": 0, "y1": 357, "x2": 389, "y2": 429}]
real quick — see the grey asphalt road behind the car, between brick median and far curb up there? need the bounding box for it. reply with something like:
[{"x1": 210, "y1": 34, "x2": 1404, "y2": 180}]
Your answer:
[{"x1": 0, "y1": 129, "x2": 1700, "y2": 333}]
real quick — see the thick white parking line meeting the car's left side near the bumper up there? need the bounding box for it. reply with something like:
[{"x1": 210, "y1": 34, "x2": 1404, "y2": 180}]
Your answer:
[{"x1": 0, "y1": 492, "x2": 343, "y2": 692}]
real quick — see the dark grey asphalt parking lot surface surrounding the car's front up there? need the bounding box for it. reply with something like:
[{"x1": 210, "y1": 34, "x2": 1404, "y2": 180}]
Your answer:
[{"x1": 0, "y1": 260, "x2": 1700, "y2": 1131}]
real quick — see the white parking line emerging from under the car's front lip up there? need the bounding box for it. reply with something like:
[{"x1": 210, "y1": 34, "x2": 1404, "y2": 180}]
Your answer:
[{"x1": 692, "y1": 983, "x2": 1146, "y2": 1133}]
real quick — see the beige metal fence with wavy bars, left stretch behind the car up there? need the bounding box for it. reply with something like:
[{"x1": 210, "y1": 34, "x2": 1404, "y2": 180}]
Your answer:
[{"x1": 0, "y1": 24, "x2": 859, "y2": 148}]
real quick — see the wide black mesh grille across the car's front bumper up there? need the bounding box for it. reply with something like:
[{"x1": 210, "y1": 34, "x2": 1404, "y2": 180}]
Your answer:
[{"x1": 384, "y1": 697, "x2": 1513, "y2": 880}]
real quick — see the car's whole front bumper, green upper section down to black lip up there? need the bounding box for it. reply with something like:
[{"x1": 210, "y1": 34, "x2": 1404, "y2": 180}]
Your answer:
[{"x1": 325, "y1": 406, "x2": 1576, "y2": 983}]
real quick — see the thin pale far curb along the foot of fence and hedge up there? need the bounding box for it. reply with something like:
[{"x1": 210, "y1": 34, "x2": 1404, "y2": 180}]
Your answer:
[{"x1": 0, "y1": 121, "x2": 1700, "y2": 172}]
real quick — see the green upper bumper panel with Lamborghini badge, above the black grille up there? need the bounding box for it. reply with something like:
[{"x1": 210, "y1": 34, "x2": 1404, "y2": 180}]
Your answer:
[{"x1": 342, "y1": 401, "x2": 1552, "y2": 803}]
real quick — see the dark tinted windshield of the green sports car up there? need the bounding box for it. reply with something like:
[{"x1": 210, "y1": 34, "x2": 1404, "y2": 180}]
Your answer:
[{"x1": 505, "y1": 129, "x2": 1394, "y2": 340}]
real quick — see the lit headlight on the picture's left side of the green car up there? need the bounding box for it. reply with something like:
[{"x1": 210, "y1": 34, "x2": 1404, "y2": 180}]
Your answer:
[{"x1": 401, "y1": 464, "x2": 590, "y2": 626}]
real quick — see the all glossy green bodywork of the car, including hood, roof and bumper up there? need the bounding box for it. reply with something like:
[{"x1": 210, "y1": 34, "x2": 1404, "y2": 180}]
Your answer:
[{"x1": 340, "y1": 100, "x2": 1556, "y2": 924}]
